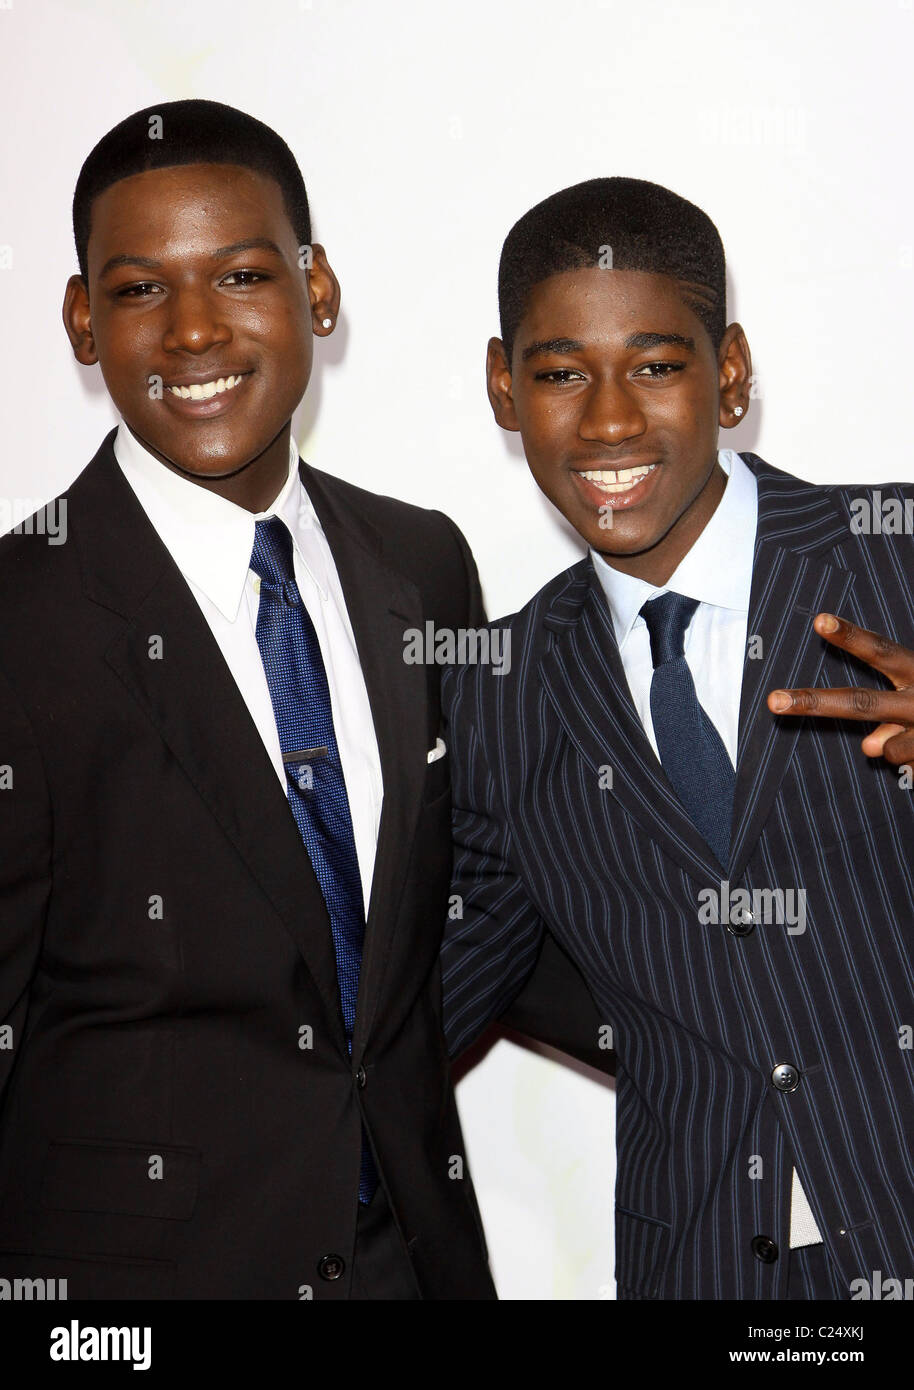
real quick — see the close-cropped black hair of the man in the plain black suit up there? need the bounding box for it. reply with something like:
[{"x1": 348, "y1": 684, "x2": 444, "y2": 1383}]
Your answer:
[{"x1": 74, "y1": 99, "x2": 311, "y2": 286}]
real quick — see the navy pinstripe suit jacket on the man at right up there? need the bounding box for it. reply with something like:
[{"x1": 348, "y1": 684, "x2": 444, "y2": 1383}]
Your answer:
[{"x1": 443, "y1": 455, "x2": 914, "y2": 1298}]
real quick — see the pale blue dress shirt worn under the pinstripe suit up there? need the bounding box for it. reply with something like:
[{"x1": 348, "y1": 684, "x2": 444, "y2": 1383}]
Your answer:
[{"x1": 590, "y1": 449, "x2": 822, "y2": 1248}]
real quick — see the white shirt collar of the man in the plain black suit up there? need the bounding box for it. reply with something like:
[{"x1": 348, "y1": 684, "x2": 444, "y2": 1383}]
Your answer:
[{"x1": 114, "y1": 421, "x2": 326, "y2": 623}]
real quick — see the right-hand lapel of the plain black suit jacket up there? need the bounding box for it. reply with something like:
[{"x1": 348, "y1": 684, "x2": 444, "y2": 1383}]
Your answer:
[{"x1": 301, "y1": 464, "x2": 428, "y2": 1056}]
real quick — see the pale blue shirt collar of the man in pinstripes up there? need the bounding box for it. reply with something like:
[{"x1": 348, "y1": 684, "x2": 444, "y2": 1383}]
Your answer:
[{"x1": 590, "y1": 449, "x2": 758, "y2": 651}]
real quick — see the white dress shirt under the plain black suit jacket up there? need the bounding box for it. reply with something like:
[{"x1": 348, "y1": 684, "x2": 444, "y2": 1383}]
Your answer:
[{"x1": 114, "y1": 421, "x2": 383, "y2": 913}]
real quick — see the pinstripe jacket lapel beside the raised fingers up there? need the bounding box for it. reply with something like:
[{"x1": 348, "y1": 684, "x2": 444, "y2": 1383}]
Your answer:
[{"x1": 729, "y1": 455, "x2": 853, "y2": 883}]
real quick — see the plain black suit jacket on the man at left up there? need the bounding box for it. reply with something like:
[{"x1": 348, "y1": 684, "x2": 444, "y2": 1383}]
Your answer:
[{"x1": 0, "y1": 431, "x2": 493, "y2": 1298}]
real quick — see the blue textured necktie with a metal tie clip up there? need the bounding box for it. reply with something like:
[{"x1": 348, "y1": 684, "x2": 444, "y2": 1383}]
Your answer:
[{"x1": 250, "y1": 517, "x2": 378, "y2": 1202}]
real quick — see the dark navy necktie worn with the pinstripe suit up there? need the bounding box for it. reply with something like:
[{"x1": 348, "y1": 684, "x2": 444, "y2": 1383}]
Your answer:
[{"x1": 640, "y1": 594, "x2": 736, "y2": 867}]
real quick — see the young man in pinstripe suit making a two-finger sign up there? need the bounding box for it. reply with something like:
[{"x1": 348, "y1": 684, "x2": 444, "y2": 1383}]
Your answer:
[{"x1": 443, "y1": 178, "x2": 914, "y2": 1298}]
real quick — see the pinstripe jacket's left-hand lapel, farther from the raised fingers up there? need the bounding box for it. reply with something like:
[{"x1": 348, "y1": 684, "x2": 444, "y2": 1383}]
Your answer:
[{"x1": 540, "y1": 559, "x2": 721, "y2": 880}]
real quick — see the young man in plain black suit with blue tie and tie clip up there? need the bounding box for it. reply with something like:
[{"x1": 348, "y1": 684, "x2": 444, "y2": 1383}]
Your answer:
[{"x1": 0, "y1": 101, "x2": 493, "y2": 1300}]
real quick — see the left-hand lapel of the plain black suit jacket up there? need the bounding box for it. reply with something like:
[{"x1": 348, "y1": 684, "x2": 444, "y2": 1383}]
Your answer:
[{"x1": 71, "y1": 431, "x2": 355, "y2": 1054}]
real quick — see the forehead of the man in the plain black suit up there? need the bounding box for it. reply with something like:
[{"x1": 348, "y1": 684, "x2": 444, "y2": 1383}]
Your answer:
[{"x1": 89, "y1": 164, "x2": 294, "y2": 261}]
